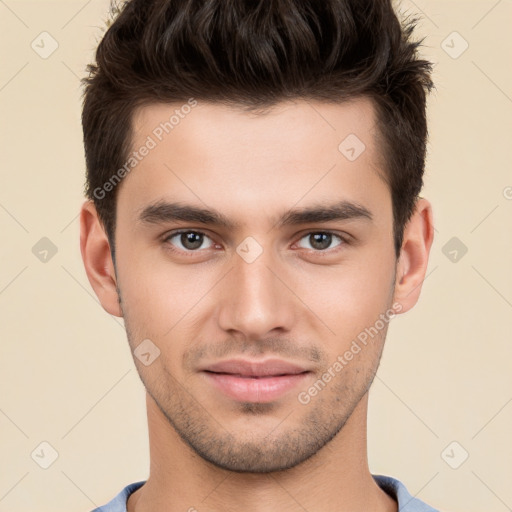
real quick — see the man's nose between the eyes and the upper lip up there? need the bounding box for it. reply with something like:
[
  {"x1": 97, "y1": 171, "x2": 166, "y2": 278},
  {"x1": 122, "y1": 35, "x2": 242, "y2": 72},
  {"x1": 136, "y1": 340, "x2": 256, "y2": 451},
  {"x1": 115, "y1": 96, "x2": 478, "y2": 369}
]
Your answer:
[{"x1": 218, "y1": 243, "x2": 300, "y2": 339}]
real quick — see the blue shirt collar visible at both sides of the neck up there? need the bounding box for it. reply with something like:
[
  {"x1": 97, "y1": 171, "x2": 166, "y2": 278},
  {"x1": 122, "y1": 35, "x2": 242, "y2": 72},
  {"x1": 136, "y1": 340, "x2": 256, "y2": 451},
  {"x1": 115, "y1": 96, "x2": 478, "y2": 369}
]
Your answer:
[{"x1": 92, "y1": 475, "x2": 439, "y2": 512}]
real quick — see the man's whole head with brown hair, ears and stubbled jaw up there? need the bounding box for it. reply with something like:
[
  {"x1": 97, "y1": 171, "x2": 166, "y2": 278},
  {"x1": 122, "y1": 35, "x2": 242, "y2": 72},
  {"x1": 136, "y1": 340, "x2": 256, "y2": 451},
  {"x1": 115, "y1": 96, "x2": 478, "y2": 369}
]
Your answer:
[{"x1": 81, "y1": 0, "x2": 432, "y2": 472}]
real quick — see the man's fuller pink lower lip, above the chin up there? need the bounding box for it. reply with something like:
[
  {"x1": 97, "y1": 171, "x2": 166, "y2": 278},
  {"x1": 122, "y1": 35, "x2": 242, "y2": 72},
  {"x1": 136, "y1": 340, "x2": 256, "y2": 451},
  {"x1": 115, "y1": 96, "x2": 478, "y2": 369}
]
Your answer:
[{"x1": 203, "y1": 372, "x2": 310, "y2": 403}]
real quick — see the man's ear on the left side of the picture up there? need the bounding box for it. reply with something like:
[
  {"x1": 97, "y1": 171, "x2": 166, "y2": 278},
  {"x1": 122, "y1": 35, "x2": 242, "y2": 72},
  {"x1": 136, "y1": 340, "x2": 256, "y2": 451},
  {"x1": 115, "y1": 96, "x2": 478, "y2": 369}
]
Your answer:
[{"x1": 80, "y1": 200, "x2": 123, "y2": 317}]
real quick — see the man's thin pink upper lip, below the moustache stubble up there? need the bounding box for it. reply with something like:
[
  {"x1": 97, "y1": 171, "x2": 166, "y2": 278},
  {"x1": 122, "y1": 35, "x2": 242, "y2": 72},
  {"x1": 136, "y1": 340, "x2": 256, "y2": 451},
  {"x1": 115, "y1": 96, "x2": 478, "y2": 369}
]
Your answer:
[{"x1": 203, "y1": 359, "x2": 309, "y2": 377}]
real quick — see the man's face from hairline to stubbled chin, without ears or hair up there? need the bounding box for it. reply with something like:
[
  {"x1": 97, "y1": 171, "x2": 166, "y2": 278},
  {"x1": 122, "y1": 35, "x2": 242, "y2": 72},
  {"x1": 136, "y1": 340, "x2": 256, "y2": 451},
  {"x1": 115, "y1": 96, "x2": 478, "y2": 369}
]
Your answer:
[{"x1": 116, "y1": 99, "x2": 396, "y2": 472}]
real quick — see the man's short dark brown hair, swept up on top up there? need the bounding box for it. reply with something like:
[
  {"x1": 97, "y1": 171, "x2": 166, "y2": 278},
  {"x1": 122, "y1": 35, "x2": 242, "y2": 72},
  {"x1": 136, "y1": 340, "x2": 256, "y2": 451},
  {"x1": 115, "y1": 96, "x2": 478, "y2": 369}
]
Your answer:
[{"x1": 82, "y1": 0, "x2": 433, "y2": 257}]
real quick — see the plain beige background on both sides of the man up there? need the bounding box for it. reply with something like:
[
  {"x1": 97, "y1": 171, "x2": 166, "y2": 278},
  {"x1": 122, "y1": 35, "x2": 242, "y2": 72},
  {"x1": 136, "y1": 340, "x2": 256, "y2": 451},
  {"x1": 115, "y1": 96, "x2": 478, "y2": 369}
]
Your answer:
[{"x1": 0, "y1": 0, "x2": 512, "y2": 512}]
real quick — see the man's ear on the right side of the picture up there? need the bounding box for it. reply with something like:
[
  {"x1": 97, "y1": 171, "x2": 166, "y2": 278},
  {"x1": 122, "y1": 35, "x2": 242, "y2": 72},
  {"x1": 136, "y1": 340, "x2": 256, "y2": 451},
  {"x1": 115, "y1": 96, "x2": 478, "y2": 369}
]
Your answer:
[{"x1": 394, "y1": 198, "x2": 434, "y2": 313}]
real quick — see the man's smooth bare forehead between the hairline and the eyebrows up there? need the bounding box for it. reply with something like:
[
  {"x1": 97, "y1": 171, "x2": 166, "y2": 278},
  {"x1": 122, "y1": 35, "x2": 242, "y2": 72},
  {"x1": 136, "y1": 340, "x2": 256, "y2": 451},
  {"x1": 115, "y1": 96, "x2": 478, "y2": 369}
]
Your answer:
[{"x1": 118, "y1": 98, "x2": 389, "y2": 229}]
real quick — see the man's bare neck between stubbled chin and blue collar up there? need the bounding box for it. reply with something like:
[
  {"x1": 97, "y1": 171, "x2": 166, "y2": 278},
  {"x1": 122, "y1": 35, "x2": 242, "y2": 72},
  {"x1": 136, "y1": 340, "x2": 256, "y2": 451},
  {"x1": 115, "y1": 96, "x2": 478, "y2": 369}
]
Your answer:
[{"x1": 127, "y1": 394, "x2": 397, "y2": 512}]
